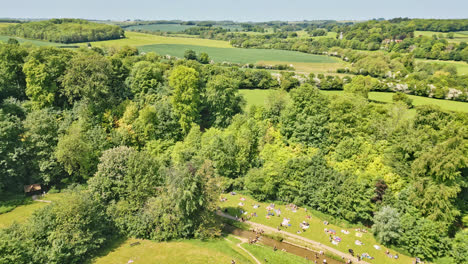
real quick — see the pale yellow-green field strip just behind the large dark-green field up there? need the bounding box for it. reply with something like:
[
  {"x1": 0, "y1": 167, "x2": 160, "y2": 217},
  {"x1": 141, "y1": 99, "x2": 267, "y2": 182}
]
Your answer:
[{"x1": 91, "y1": 31, "x2": 233, "y2": 48}]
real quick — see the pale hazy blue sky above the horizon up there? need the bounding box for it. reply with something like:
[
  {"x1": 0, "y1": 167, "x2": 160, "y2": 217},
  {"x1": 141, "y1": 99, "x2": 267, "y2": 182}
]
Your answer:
[{"x1": 0, "y1": 0, "x2": 468, "y2": 21}]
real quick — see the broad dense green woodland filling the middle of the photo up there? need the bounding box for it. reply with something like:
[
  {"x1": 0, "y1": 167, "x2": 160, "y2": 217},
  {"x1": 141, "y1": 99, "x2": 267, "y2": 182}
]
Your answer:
[{"x1": 0, "y1": 41, "x2": 468, "y2": 263}]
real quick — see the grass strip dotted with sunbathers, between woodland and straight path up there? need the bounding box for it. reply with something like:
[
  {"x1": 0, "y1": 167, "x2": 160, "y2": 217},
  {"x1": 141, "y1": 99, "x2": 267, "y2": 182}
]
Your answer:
[{"x1": 220, "y1": 194, "x2": 412, "y2": 264}]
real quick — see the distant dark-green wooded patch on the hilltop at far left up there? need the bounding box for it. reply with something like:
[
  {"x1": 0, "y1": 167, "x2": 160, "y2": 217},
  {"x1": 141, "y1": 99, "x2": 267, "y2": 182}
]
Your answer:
[{"x1": 0, "y1": 19, "x2": 125, "y2": 44}]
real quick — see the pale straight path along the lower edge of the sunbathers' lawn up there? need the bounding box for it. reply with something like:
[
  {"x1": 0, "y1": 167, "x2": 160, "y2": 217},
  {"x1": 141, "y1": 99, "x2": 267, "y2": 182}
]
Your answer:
[{"x1": 217, "y1": 211, "x2": 369, "y2": 264}]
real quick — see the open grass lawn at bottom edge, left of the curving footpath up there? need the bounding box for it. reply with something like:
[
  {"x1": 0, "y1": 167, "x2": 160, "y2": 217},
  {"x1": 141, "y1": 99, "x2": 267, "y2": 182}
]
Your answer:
[{"x1": 93, "y1": 238, "x2": 253, "y2": 264}]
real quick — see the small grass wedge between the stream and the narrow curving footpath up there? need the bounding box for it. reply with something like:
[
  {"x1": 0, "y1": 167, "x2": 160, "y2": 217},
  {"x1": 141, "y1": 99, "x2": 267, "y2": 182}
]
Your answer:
[{"x1": 242, "y1": 243, "x2": 311, "y2": 264}]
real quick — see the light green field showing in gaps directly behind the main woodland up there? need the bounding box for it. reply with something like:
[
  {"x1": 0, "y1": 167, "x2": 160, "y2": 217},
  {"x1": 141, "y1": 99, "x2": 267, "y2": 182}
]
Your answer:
[{"x1": 239, "y1": 89, "x2": 468, "y2": 113}]
